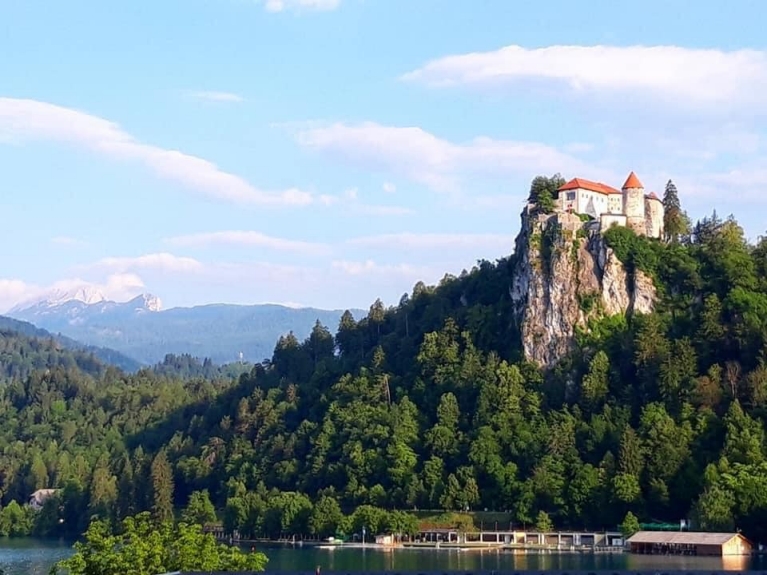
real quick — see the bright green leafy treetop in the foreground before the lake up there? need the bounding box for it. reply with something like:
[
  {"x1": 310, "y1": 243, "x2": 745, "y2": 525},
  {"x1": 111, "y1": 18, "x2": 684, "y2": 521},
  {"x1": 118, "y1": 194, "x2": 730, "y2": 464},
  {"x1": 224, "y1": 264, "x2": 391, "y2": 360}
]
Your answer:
[{"x1": 57, "y1": 513, "x2": 267, "y2": 575}]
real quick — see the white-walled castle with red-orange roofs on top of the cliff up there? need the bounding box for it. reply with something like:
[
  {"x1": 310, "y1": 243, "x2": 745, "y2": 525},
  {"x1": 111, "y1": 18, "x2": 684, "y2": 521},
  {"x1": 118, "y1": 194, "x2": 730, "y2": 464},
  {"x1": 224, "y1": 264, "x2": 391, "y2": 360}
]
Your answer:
[{"x1": 557, "y1": 172, "x2": 663, "y2": 238}]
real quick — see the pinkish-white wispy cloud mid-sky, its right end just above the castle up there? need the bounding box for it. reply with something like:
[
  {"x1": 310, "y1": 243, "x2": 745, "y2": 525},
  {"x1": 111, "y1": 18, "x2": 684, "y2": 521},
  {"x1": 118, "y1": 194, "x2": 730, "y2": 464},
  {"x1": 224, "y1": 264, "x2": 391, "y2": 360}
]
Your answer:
[{"x1": 297, "y1": 122, "x2": 598, "y2": 191}]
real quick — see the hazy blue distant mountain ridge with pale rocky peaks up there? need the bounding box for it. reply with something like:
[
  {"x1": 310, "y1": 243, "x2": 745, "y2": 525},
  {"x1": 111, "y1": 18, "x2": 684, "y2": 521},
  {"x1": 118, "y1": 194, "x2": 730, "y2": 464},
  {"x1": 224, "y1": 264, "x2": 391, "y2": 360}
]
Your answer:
[{"x1": 7, "y1": 289, "x2": 365, "y2": 365}]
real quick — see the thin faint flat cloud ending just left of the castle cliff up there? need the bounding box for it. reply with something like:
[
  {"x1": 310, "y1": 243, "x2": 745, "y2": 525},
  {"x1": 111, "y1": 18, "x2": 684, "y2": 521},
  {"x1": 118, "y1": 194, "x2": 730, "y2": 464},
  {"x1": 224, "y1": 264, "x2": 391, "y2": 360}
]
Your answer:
[{"x1": 348, "y1": 232, "x2": 514, "y2": 252}]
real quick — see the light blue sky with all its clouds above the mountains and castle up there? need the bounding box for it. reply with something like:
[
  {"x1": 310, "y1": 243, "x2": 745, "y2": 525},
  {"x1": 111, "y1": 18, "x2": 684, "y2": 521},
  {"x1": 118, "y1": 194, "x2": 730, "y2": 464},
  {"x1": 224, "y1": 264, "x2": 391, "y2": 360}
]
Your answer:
[{"x1": 0, "y1": 0, "x2": 767, "y2": 311}]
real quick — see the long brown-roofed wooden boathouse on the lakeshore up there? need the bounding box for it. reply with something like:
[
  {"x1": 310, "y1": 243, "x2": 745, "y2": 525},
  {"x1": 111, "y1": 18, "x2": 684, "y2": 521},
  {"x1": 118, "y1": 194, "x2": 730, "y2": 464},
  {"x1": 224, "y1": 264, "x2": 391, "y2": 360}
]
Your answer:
[{"x1": 626, "y1": 531, "x2": 753, "y2": 557}]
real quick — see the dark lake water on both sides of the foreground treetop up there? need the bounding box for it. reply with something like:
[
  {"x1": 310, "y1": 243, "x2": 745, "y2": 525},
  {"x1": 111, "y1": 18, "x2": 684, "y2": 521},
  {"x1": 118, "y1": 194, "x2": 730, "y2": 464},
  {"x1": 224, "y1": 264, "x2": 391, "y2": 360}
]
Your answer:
[{"x1": 0, "y1": 539, "x2": 767, "y2": 575}]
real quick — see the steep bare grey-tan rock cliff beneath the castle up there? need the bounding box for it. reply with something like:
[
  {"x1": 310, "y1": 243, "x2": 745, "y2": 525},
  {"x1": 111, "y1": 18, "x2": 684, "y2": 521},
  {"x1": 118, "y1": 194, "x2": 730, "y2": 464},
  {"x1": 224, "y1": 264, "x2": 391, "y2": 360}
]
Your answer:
[{"x1": 510, "y1": 207, "x2": 656, "y2": 367}]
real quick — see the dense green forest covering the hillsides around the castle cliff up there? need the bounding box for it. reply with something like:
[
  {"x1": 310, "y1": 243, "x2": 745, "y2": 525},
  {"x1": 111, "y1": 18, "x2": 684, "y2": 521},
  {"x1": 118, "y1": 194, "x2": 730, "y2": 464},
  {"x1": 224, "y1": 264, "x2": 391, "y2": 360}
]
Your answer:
[{"x1": 0, "y1": 178, "x2": 767, "y2": 541}]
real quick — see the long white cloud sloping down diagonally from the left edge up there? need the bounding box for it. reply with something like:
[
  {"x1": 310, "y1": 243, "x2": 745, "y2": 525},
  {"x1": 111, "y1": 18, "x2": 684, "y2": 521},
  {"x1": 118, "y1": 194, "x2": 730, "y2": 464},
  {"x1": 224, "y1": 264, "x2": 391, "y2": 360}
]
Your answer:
[{"x1": 0, "y1": 98, "x2": 312, "y2": 206}]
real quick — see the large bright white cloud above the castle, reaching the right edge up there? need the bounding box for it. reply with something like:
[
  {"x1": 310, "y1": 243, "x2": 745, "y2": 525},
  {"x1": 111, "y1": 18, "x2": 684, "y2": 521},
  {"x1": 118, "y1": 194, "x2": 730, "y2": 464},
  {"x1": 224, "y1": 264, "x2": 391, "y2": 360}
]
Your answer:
[{"x1": 403, "y1": 45, "x2": 767, "y2": 108}]
